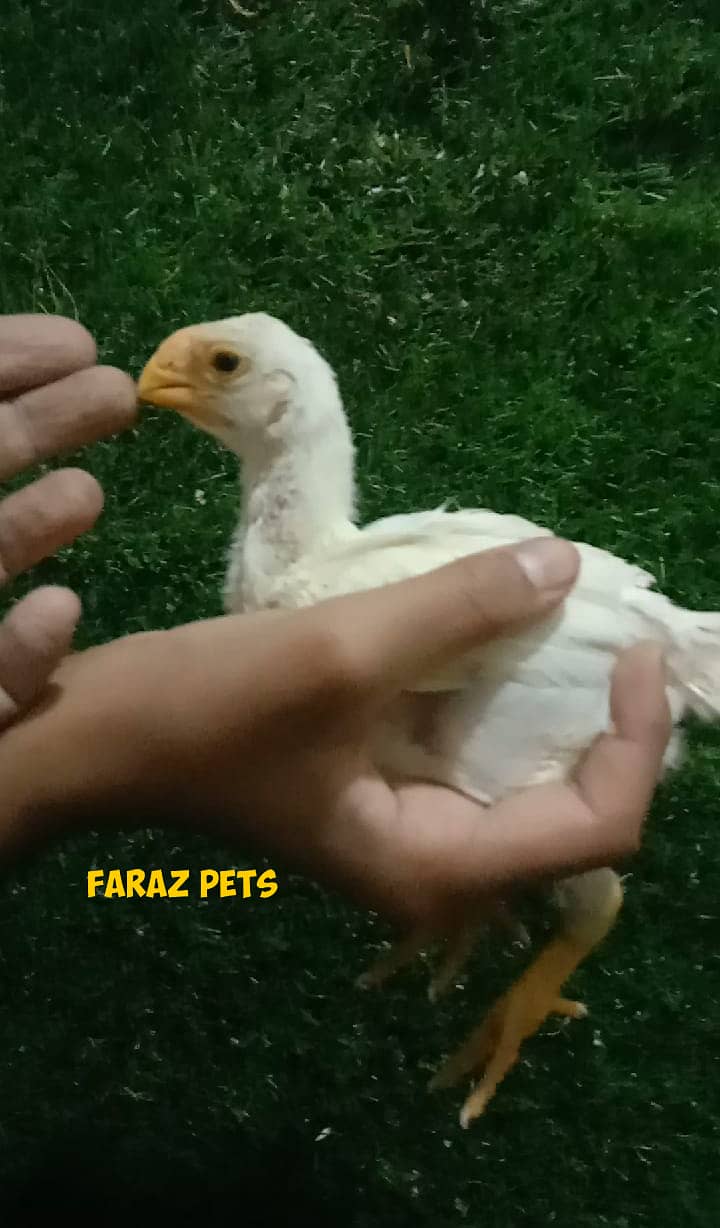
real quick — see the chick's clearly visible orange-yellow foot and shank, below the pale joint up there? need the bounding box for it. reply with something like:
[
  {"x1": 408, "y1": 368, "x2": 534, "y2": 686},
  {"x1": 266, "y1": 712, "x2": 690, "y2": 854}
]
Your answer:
[{"x1": 430, "y1": 939, "x2": 587, "y2": 1129}]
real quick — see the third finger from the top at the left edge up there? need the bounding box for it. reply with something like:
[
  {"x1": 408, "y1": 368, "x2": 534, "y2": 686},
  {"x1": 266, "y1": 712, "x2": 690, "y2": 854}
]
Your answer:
[{"x1": 0, "y1": 469, "x2": 103, "y2": 583}]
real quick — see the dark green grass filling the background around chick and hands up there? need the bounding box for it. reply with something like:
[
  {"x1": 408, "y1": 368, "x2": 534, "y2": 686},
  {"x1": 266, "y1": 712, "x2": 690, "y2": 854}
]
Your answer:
[{"x1": 0, "y1": 0, "x2": 720, "y2": 1228}]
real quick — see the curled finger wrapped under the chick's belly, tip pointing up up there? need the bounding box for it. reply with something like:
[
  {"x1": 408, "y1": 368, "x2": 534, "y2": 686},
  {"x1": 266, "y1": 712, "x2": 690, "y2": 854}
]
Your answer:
[{"x1": 333, "y1": 645, "x2": 672, "y2": 920}]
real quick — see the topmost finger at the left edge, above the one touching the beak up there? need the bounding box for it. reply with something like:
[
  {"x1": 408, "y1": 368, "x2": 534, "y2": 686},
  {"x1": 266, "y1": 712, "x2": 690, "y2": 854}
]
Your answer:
[{"x1": 0, "y1": 314, "x2": 97, "y2": 397}]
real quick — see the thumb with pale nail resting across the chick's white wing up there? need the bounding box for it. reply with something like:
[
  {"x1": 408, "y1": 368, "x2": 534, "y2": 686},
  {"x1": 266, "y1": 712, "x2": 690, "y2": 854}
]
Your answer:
[{"x1": 324, "y1": 537, "x2": 580, "y2": 690}]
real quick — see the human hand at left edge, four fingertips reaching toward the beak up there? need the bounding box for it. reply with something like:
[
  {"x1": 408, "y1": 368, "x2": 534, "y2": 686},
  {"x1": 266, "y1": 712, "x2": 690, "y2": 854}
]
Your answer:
[{"x1": 0, "y1": 314, "x2": 136, "y2": 727}]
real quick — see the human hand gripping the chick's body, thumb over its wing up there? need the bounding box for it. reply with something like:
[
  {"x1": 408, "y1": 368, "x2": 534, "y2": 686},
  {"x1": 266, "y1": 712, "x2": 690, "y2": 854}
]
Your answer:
[{"x1": 0, "y1": 539, "x2": 671, "y2": 927}]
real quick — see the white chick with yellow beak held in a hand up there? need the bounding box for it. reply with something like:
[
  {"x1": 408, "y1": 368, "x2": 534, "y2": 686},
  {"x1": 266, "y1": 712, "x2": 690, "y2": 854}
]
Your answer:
[{"x1": 139, "y1": 313, "x2": 720, "y2": 1125}]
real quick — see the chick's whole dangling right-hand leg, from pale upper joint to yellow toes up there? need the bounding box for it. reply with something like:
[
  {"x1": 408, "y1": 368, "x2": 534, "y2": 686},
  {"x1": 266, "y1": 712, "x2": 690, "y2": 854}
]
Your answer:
[{"x1": 430, "y1": 869, "x2": 623, "y2": 1127}]
